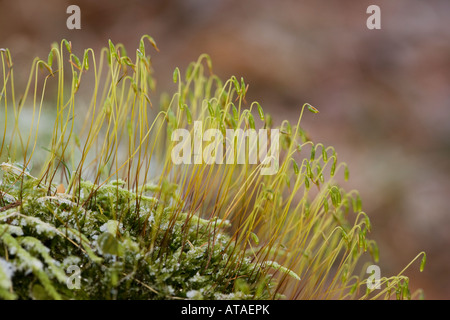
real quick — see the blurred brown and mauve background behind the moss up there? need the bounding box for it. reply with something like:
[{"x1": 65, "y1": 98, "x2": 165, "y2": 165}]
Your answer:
[{"x1": 0, "y1": 0, "x2": 450, "y2": 299}]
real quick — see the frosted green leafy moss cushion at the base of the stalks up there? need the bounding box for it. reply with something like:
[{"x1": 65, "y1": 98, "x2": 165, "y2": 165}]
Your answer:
[{"x1": 0, "y1": 166, "x2": 270, "y2": 299}]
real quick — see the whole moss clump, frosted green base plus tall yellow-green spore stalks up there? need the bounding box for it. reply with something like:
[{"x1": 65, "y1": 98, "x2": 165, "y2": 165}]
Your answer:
[{"x1": 0, "y1": 36, "x2": 425, "y2": 299}]
